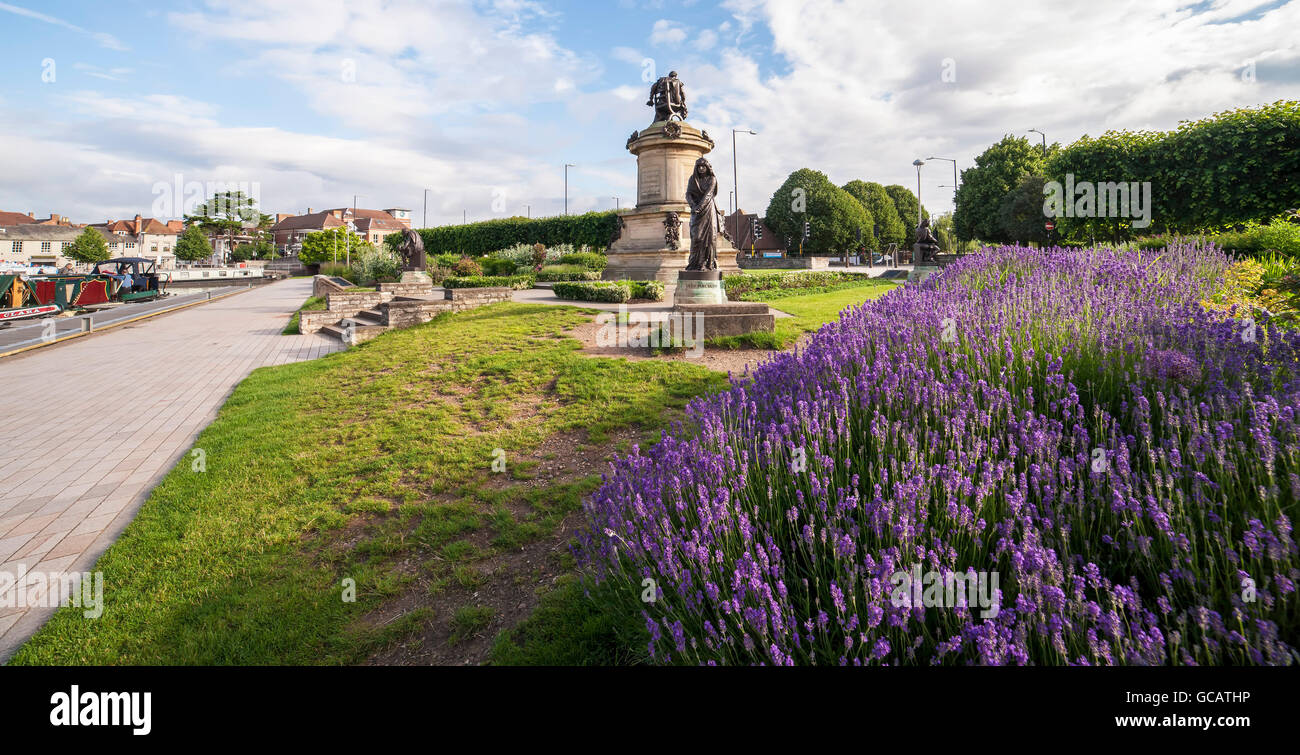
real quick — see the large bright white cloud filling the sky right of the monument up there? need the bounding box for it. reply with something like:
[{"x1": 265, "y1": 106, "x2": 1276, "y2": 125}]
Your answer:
[{"x1": 683, "y1": 0, "x2": 1300, "y2": 217}]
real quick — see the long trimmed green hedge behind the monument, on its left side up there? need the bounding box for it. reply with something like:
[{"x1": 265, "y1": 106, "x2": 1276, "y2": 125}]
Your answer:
[{"x1": 420, "y1": 212, "x2": 619, "y2": 257}]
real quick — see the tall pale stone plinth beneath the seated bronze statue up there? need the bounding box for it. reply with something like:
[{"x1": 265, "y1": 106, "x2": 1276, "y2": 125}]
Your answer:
[{"x1": 605, "y1": 121, "x2": 740, "y2": 283}]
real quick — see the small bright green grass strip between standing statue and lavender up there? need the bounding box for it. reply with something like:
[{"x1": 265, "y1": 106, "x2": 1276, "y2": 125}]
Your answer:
[{"x1": 707, "y1": 281, "x2": 896, "y2": 350}]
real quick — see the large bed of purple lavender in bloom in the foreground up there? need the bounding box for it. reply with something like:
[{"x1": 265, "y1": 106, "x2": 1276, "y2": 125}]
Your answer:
[{"x1": 577, "y1": 246, "x2": 1300, "y2": 664}]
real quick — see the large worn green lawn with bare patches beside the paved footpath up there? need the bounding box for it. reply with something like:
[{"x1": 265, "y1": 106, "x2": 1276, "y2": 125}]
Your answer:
[{"x1": 10, "y1": 303, "x2": 725, "y2": 665}]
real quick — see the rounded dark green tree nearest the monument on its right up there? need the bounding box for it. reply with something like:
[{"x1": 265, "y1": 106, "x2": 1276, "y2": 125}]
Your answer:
[{"x1": 763, "y1": 168, "x2": 874, "y2": 255}]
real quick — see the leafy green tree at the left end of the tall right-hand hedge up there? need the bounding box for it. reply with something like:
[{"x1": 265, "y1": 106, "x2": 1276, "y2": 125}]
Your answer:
[{"x1": 953, "y1": 134, "x2": 1060, "y2": 242}]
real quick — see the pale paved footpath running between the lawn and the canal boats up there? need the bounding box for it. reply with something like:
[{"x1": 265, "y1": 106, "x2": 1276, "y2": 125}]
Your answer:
[{"x1": 0, "y1": 278, "x2": 342, "y2": 661}]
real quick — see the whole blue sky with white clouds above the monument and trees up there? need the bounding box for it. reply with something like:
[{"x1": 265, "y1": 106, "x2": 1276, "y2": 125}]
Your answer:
[{"x1": 0, "y1": 0, "x2": 1300, "y2": 225}]
